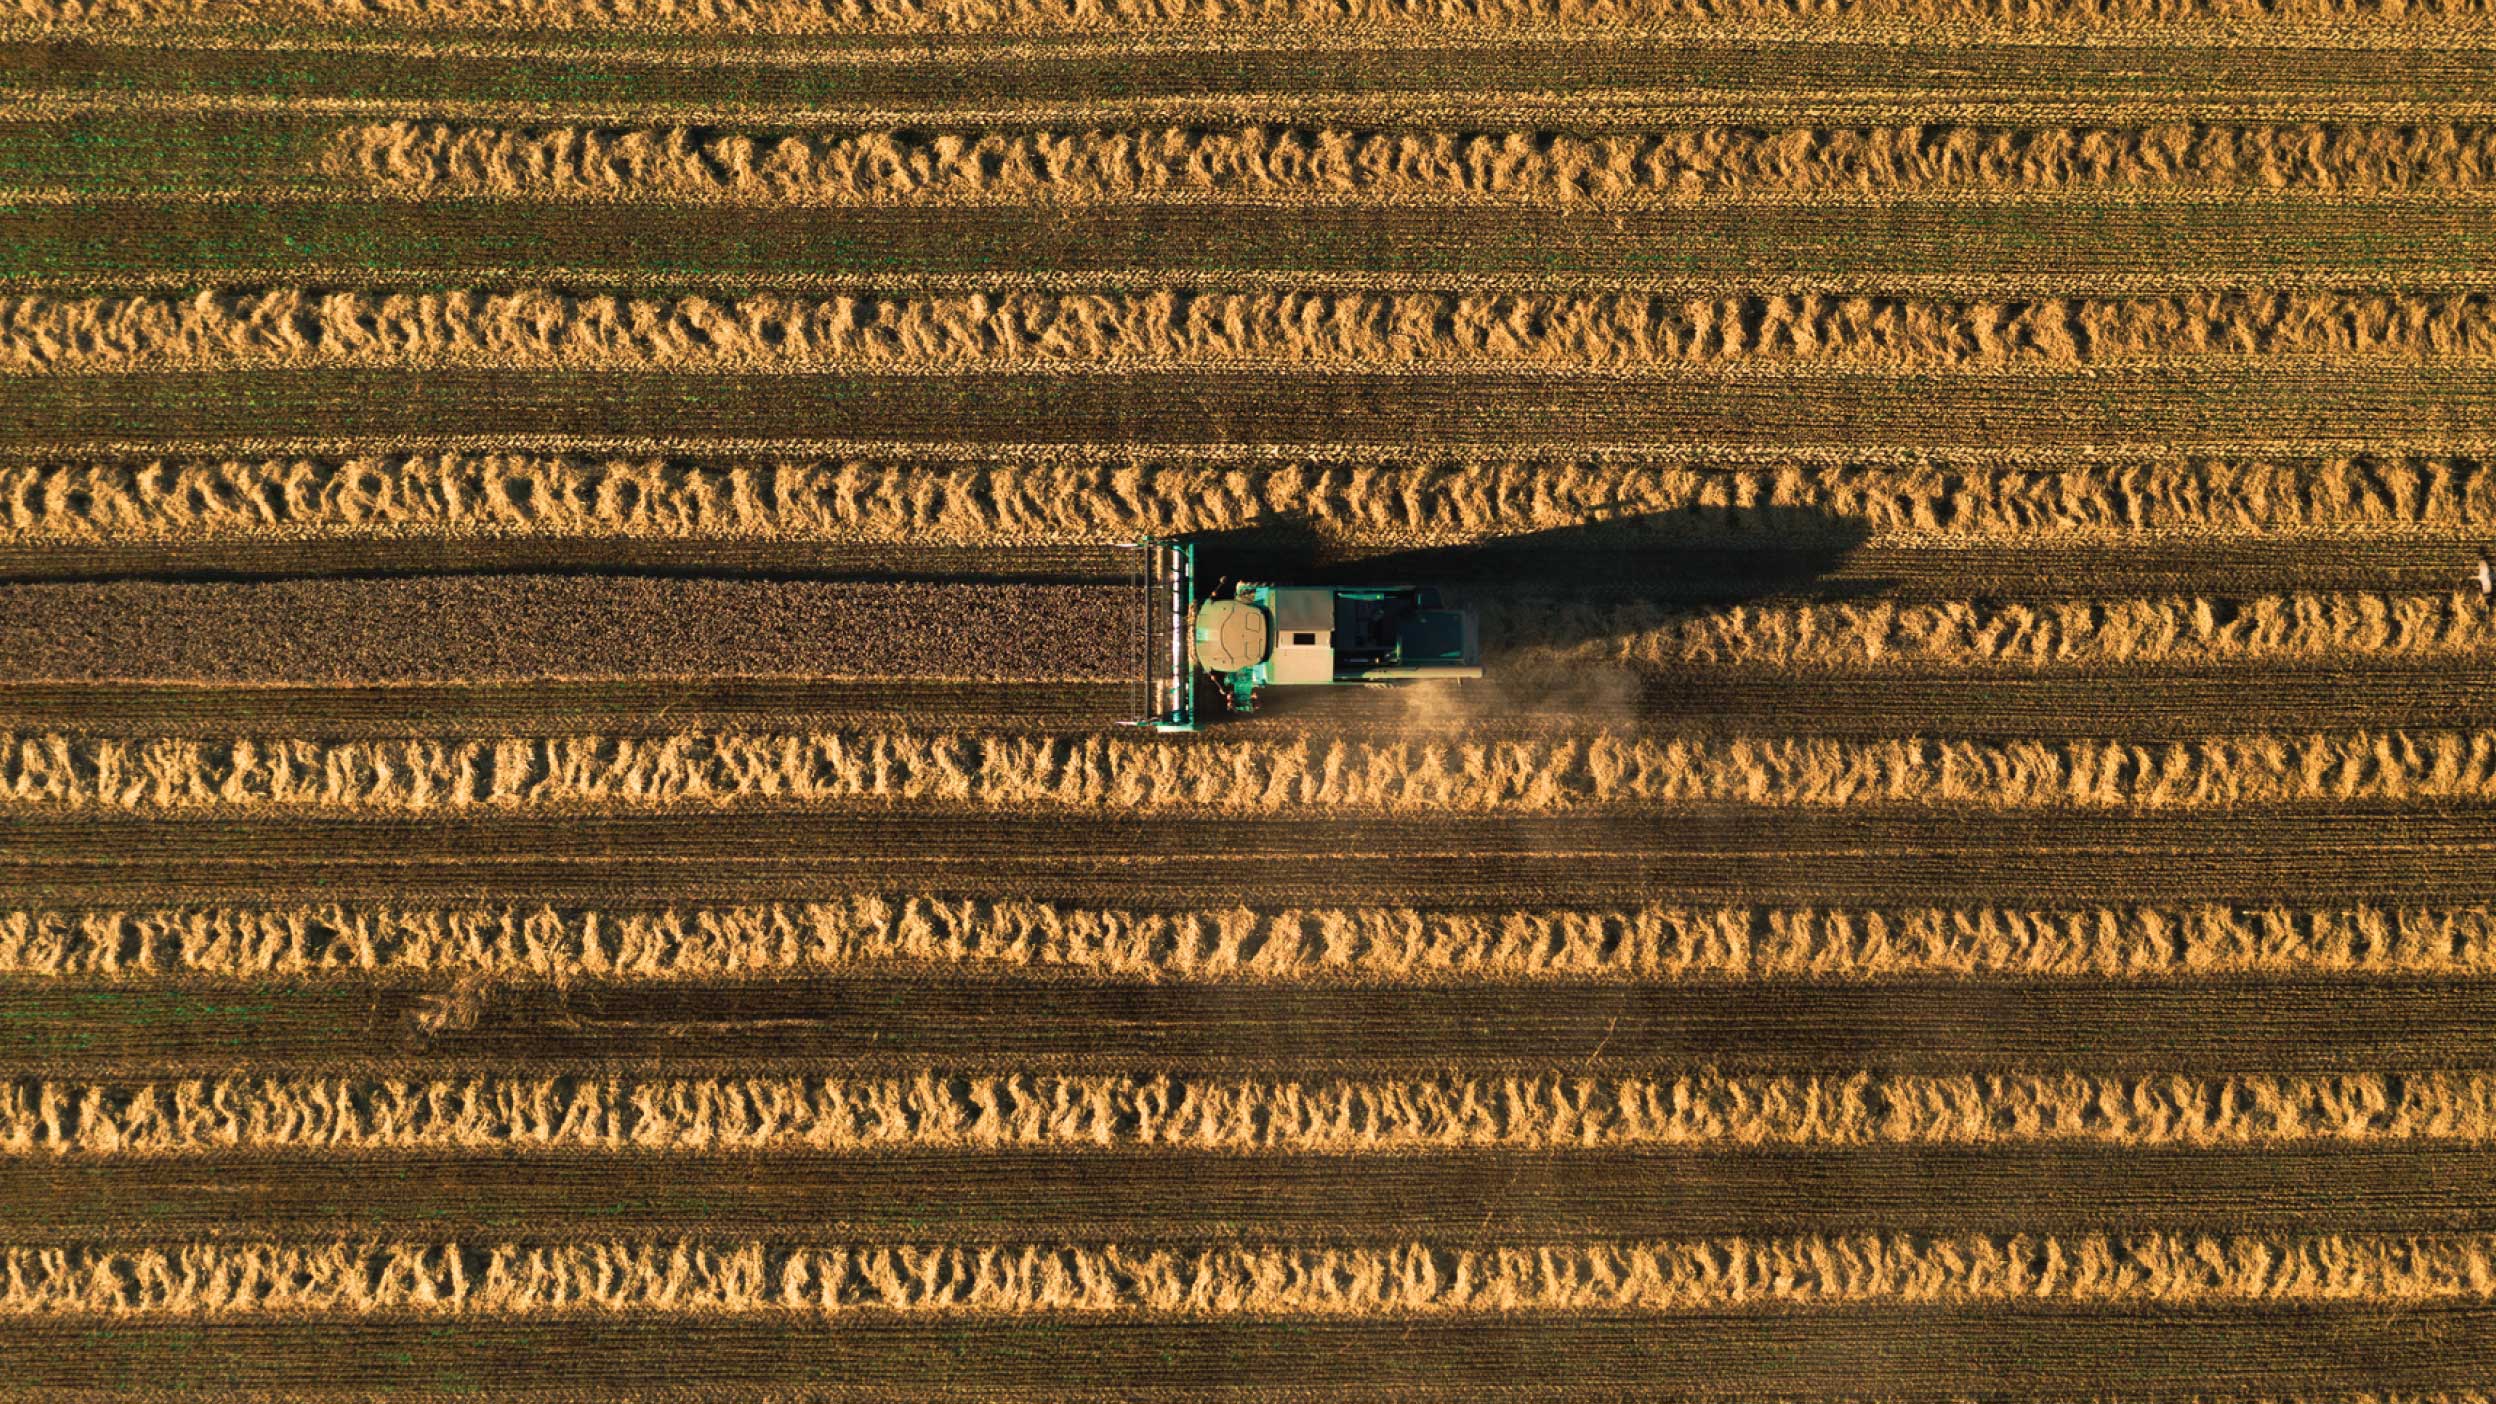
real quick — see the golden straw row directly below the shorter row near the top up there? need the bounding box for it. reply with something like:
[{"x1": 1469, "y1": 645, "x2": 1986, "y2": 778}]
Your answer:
[{"x1": 14, "y1": 287, "x2": 2496, "y2": 375}]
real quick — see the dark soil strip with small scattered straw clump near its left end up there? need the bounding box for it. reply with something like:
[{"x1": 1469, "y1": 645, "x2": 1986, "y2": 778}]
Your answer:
[{"x1": 0, "y1": 977, "x2": 2496, "y2": 1077}]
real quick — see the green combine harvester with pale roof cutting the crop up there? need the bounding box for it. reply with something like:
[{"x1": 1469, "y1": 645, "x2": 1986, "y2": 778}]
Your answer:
[{"x1": 1136, "y1": 542, "x2": 1483, "y2": 732}]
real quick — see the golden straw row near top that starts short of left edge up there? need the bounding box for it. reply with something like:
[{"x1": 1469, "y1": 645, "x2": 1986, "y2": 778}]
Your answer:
[{"x1": 319, "y1": 120, "x2": 2496, "y2": 205}]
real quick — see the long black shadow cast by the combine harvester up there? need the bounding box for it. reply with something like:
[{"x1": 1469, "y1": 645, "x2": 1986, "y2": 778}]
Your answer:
[{"x1": 1193, "y1": 507, "x2": 1889, "y2": 717}]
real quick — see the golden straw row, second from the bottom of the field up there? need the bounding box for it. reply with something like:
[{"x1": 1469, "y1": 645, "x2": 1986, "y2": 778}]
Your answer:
[{"x1": 19, "y1": 1072, "x2": 2496, "y2": 1157}]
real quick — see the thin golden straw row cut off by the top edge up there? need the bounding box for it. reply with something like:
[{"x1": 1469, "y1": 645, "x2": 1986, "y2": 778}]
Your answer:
[{"x1": 19, "y1": 0, "x2": 2491, "y2": 30}]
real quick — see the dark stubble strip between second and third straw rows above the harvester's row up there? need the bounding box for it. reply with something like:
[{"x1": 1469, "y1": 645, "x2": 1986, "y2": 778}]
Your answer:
[{"x1": 0, "y1": 357, "x2": 2496, "y2": 452}]
